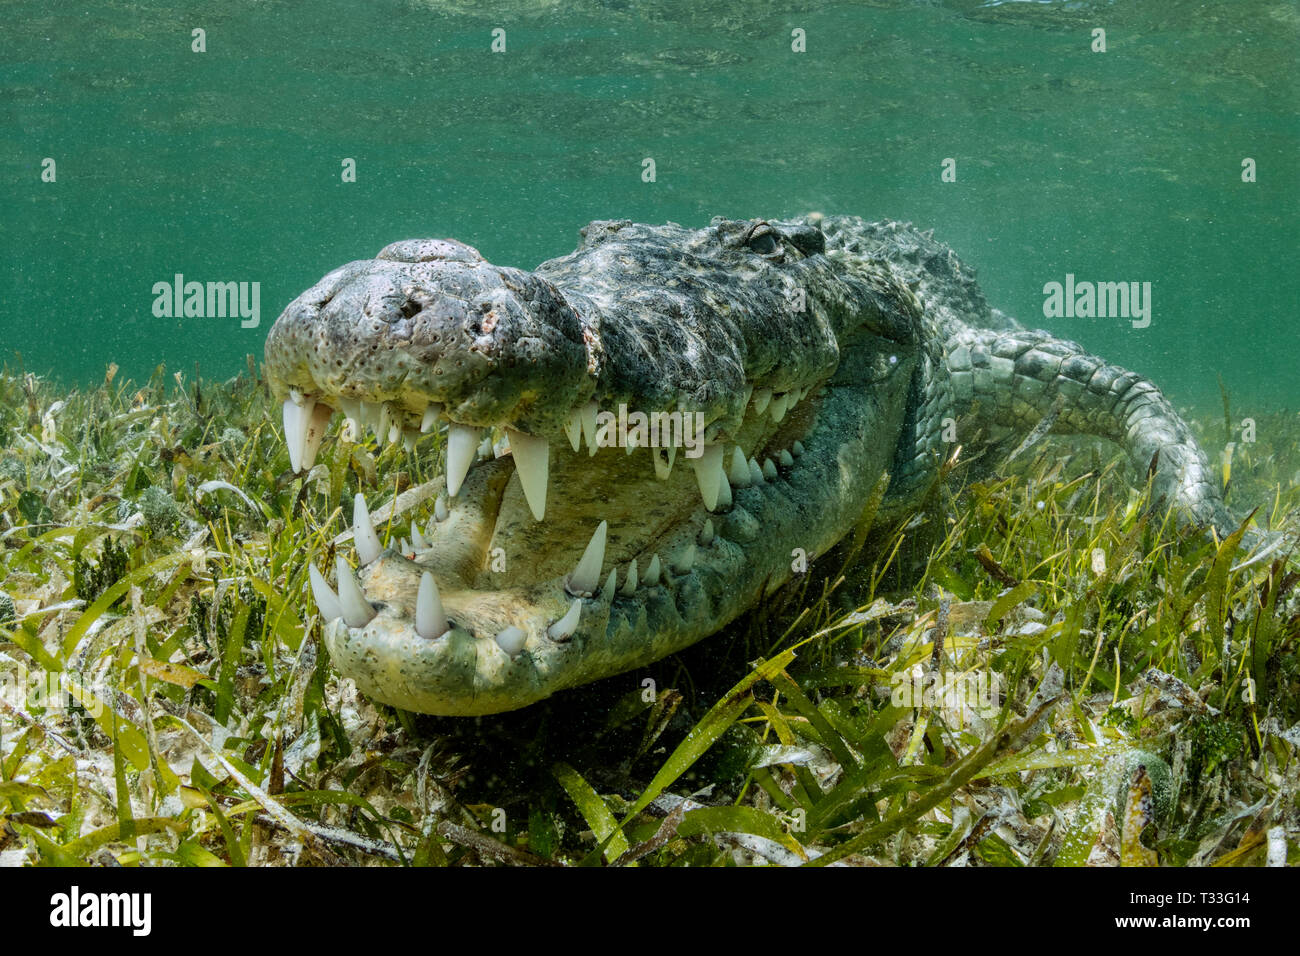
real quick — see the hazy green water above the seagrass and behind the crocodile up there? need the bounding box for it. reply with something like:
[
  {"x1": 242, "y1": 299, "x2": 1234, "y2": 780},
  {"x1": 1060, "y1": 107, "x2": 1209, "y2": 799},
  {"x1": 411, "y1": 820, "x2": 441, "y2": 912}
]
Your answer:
[{"x1": 0, "y1": 0, "x2": 1300, "y2": 414}]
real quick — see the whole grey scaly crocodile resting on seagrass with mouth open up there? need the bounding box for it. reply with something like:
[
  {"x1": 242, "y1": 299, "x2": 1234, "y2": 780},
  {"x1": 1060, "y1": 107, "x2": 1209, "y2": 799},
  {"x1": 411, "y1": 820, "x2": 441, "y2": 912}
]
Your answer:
[{"x1": 265, "y1": 215, "x2": 1231, "y2": 715}]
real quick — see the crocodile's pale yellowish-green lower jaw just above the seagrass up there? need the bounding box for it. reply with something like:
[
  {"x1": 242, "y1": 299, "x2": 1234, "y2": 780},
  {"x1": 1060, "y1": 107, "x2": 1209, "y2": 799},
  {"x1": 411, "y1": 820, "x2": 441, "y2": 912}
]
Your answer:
[{"x1": 325, "y1": 389, "x2": 904, "y2": 715}]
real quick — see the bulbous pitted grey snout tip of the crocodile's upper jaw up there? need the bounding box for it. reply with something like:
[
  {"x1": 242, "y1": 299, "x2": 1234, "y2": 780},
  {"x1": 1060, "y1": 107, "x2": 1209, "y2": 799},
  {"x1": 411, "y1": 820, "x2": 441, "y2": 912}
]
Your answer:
[{"x1": 265, "y1": 239, "x2": 598, "y2": 437}]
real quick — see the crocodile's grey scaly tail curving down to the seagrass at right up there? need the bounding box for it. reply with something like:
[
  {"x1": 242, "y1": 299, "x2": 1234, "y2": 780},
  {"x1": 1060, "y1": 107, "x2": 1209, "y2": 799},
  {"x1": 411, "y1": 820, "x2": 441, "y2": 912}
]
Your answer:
[{"x1": 944, "y1": 329, "x2": 1236, "y2": 535}]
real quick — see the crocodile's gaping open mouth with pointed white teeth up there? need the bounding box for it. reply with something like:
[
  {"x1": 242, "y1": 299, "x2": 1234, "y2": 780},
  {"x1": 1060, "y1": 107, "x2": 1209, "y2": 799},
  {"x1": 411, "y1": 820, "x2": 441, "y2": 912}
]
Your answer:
[{"x1": 283, "y1": 377, "x2": 819, "y2": 713}]
